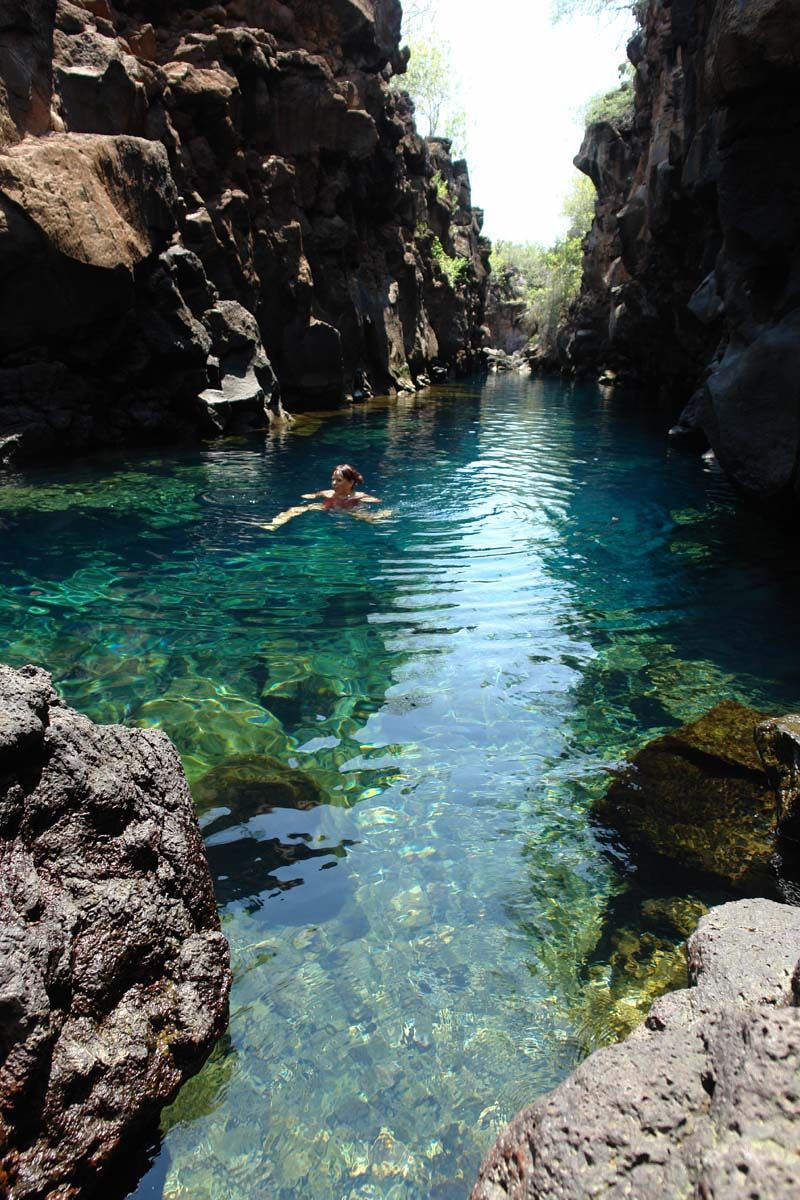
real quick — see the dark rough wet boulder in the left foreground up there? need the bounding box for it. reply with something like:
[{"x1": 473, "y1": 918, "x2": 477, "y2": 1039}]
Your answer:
[{"x1": 0, "y1": 666, "x2": 230, "y2": 1200}]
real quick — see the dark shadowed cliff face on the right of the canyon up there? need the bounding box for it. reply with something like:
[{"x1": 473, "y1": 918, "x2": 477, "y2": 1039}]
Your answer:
[{"x1": 561, "y1": 0, "x2": 800, "y2": 506}]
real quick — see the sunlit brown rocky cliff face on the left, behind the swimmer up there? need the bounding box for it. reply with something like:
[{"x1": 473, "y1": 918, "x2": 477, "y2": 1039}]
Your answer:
[{"x1": 0, "y1": 0, "x2": 488, "y2": 456}]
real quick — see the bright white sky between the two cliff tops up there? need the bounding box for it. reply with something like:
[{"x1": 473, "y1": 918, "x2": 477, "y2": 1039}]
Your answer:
[{"x1": 410, "y1": 0, "x2": 633, "y2": 245}]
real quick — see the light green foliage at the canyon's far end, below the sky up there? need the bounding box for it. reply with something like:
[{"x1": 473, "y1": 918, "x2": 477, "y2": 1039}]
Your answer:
[{"x1": 489, "y1": 175, "x2": 595, "y2": 354}]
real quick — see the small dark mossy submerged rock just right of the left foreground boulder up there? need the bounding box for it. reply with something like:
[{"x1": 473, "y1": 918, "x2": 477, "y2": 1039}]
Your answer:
[{"x1": 192, "y1": 755, "x2": 326, "y2": 822}]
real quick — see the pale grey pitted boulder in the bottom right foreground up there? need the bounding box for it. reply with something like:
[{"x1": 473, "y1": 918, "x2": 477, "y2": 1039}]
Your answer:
[{"x1": 471, "y1": 900, "x2": 800, "y2": 1200}]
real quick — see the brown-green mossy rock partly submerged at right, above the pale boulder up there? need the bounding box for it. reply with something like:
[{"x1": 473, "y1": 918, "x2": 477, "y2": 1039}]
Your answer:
[{"x1": 593, "y1": 701, "x2": 775, "y2": 888}]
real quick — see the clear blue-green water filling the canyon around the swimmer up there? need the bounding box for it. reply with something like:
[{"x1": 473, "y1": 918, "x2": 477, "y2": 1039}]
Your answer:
[{"x1": 0, "y1": 369, "x2": 800, "y2": 1200}]
